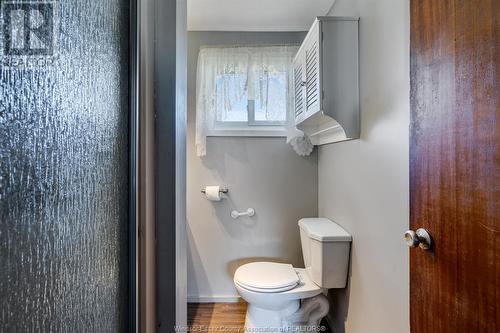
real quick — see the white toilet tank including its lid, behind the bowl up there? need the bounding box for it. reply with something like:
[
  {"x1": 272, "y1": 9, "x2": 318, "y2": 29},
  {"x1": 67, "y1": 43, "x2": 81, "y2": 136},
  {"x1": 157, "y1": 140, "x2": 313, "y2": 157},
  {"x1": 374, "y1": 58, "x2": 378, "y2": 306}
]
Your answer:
[{"x1": 299, "y1": 218, "x2": 352, "y2": 289}]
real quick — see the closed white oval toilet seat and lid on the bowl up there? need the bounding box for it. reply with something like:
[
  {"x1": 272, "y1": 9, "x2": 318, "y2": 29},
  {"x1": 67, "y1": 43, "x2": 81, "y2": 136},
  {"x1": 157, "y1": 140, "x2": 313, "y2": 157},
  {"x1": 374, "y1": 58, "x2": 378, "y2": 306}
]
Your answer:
[{"x1": 234, "y1": 262, "x2": 300, "y2": 293}]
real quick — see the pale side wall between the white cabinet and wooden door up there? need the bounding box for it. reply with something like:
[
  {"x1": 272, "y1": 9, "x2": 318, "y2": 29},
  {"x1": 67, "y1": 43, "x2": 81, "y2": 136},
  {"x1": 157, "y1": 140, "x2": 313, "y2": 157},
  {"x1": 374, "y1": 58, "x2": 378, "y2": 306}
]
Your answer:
[{"x1": 318, "y1": 0, "x2": 410, "y2": 333}]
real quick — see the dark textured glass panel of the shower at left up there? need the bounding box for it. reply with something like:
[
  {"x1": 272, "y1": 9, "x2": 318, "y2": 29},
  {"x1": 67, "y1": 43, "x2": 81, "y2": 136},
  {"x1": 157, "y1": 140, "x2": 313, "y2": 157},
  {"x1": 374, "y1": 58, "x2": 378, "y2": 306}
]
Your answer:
[{"x1": 0, "y1": 0, "x2": 129, "y2": 332}]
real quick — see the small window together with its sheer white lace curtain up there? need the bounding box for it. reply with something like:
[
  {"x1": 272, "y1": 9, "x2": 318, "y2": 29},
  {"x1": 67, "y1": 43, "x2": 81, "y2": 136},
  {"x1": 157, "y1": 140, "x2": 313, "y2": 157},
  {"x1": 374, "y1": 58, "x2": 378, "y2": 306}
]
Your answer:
[{"x1": 196, "y1": 46, "x2": 298, "y2": 156}]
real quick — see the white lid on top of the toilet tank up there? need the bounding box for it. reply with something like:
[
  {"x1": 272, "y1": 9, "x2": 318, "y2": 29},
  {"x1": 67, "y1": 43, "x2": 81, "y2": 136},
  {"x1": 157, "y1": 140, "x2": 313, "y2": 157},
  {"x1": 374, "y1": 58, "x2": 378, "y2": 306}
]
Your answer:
[{"x1": 299, "y1": 217, "x2": 352, "y2": 242}]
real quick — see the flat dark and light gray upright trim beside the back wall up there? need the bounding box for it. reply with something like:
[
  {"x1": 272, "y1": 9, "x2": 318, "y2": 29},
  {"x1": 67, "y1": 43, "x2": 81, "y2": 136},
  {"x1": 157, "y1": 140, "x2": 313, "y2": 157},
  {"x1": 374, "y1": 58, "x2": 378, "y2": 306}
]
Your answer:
[{"x1": 154, "y1": 0, "x2": 186, "y2": 333}]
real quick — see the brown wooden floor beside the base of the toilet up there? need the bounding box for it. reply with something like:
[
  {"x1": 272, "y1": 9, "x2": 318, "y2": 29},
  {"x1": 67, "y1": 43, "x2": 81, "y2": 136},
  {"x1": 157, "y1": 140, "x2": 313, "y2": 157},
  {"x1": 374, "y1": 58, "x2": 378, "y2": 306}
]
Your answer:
[{"x1": 187, "y1": 301, "x2": 331, "y2": 333}]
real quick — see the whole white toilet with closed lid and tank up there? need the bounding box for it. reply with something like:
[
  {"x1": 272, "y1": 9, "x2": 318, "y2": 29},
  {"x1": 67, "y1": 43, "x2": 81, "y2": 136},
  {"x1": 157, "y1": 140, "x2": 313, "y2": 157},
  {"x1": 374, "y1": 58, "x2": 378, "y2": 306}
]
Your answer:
[{"x1": 234, "y1": 218, "x2": 352, "y2": 332}]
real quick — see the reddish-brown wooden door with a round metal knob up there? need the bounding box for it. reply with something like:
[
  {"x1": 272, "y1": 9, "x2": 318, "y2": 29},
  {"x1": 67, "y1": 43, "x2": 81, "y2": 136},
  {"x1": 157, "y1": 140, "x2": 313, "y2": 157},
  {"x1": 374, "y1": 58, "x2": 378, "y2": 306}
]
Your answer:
[{"x1": 410, "y1": 0, "x2": 500, "y2": 333}]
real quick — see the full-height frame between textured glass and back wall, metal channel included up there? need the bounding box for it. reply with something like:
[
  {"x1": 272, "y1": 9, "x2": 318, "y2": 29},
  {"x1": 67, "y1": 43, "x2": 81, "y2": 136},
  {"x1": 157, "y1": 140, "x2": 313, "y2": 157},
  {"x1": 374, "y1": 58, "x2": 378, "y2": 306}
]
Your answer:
[{"x1": 134, "y1": 0, "x2": 187, "y2": 333}]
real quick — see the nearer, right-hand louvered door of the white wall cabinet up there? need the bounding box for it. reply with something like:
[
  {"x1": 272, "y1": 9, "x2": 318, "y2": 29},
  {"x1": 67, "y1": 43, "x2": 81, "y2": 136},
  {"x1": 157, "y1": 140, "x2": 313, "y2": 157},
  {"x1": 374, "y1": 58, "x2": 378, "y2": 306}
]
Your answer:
[{"x1": 305, "y1": 24, "x2": 321, "y2": 115}]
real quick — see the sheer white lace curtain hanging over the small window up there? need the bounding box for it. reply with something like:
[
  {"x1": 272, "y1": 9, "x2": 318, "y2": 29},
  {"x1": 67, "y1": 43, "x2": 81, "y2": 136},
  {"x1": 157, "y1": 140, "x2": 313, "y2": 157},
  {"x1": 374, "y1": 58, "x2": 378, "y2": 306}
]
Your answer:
[{"x1": 195, "y1": 45, "x2": 298, "y2": 156}]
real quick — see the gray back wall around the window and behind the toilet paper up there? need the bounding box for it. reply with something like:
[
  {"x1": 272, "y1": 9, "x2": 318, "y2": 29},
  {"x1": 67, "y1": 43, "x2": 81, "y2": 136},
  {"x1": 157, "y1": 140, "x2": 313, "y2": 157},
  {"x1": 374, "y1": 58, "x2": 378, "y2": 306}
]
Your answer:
[{"x1": 187, "y1": 32, "x2": 318, "y2": 301}]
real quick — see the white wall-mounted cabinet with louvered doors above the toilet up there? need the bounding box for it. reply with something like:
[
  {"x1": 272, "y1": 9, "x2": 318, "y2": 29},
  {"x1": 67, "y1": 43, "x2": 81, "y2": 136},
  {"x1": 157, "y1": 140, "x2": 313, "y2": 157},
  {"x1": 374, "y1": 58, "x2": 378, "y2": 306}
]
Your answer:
[{"x1": 293, "y1": 17, "x2": 360, "y2": 145}]
